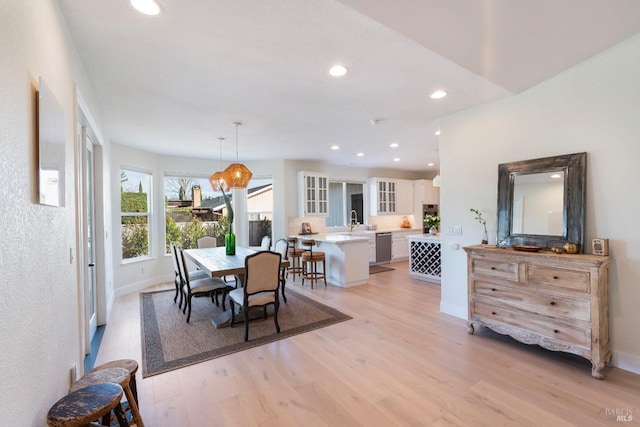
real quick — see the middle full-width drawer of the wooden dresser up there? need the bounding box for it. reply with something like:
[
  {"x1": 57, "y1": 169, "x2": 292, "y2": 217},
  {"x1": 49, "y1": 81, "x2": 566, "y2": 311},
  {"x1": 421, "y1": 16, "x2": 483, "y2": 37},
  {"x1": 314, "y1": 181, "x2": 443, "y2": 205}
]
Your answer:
[{"x1": 475, "y1": 281, "x2": 591, "y2": 322}]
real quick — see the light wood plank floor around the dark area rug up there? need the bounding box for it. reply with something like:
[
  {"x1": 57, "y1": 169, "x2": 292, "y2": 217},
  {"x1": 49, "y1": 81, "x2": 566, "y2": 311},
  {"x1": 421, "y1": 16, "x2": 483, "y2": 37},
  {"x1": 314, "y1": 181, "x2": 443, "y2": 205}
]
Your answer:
[{"x1": 96, "y1": 262, "x2": 640, "y2": 427}]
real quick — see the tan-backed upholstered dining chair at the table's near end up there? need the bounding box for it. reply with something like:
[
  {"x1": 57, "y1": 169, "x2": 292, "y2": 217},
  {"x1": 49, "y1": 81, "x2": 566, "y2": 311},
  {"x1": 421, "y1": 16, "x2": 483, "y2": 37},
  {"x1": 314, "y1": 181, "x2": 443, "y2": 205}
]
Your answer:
[{"x1": 229, "y1": 251, "x2": 281, "y2": 341}]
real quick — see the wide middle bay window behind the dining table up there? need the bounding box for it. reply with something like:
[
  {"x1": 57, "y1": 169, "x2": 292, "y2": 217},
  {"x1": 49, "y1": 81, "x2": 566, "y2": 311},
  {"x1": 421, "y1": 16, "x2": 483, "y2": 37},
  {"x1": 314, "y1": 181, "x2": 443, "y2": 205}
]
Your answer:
[{"x1": 164, "y1": 174, "x2": 231, "y2": 253}]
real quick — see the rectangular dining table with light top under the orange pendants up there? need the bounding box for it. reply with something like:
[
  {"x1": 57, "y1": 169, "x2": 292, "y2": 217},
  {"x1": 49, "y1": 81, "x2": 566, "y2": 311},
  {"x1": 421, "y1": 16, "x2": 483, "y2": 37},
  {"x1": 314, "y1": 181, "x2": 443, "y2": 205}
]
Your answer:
[{"x1": 184, "y1": 246, "x2": 289, "y2": 328}]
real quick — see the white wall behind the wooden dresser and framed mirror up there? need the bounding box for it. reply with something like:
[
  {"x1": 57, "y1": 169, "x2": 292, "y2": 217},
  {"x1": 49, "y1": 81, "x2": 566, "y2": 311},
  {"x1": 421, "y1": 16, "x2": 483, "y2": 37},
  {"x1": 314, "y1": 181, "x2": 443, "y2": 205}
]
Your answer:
[{"x1": 440, "y1": 35, "x2": 640, "y2": 373}]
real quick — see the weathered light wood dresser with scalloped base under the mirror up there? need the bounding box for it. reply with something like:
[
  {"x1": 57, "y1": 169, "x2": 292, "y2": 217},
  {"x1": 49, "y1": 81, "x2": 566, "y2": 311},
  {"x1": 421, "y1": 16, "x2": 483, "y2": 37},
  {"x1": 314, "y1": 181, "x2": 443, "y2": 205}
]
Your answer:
[{"x1": 464, "y1": 246, "x2": 611, "y2": 379}]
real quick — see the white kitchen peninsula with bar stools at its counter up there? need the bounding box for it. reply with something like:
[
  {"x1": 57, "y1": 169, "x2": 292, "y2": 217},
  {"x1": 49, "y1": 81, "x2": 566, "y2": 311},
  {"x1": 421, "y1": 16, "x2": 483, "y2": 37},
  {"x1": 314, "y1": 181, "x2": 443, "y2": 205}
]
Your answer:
[{"x1": 291, "y1": 233, "x2": 369, "y2": 288}]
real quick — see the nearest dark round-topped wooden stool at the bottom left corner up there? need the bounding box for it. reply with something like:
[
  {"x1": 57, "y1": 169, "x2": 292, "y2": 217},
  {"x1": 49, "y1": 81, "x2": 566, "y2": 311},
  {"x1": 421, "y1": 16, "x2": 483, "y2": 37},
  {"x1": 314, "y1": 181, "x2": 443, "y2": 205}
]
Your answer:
[{"x1": 47, "y1": 383, "x2": 129, "y2": 427}]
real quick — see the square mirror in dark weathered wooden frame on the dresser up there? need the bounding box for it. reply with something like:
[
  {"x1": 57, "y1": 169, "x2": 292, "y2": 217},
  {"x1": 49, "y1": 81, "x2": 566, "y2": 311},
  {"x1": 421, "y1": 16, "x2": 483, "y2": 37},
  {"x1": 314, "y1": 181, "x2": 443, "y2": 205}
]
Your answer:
[{"x1": 498, "y1": 153, "x2": 587, "y2": 252}]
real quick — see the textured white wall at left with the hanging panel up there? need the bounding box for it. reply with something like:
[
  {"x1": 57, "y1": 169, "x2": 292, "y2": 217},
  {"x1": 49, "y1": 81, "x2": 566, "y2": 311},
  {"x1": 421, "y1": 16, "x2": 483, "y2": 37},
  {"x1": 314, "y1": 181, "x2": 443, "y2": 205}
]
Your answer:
[{"x1": 0, "y1": 0, "x2": 106, "y2": 426}]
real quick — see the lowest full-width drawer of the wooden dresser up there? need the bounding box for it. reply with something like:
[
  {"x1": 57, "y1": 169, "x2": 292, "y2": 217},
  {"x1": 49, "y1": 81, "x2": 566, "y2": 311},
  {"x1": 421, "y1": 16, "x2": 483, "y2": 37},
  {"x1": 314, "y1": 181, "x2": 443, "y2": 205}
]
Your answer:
[{"x1": 471, "y1": 301, "x2": 591, "y2": 349}]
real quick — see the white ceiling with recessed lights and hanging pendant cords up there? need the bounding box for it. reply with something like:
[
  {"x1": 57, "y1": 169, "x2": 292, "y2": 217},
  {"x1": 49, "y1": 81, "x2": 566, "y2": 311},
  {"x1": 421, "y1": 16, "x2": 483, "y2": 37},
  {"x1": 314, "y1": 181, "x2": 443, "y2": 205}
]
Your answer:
[{"x1": 58, "y1": 0, "x2": 640, "y2": 171}]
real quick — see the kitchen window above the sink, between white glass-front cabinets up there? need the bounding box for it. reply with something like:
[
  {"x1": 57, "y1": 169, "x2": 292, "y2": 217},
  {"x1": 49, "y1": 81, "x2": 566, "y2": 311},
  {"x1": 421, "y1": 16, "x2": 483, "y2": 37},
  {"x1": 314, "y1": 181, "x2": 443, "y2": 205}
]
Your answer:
[{"x1": 326, "y1": 181, "x2": 364, "y2": 227}]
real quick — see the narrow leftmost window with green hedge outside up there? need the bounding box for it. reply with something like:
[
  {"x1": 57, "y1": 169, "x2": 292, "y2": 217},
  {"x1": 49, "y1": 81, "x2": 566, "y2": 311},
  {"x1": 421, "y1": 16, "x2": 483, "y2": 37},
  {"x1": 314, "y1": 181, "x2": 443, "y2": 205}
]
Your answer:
[{"x1": 120, "y1": 168, "x2": 151, "y2": 262}]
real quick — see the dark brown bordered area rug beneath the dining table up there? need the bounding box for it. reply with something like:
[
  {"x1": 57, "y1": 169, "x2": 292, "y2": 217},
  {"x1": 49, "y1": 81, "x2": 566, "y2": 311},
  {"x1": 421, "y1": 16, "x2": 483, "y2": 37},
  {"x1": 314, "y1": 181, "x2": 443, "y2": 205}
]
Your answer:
[{"x1": 140, "y1": 290, "x2": 351, "y2": 377}]
